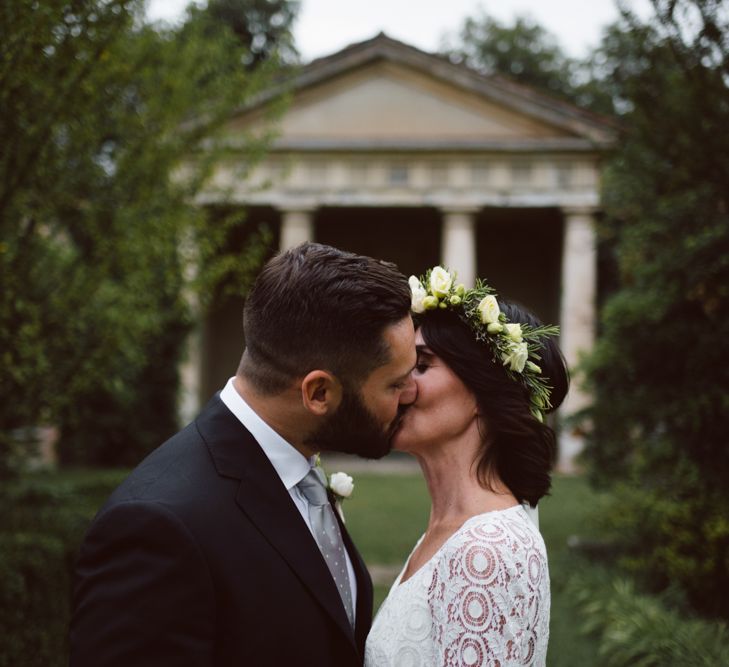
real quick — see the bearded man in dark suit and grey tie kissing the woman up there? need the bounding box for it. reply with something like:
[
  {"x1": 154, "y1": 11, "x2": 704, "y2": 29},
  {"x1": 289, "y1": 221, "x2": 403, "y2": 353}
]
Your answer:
[{"x1": 71, "y1": 244, "x2": 415, "y2": 667}]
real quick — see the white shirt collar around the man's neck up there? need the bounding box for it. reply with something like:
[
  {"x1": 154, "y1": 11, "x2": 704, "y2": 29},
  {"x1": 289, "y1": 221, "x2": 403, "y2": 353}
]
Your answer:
[{"x1": 220, "y1": 378, "x2": 313, "y2": 490}]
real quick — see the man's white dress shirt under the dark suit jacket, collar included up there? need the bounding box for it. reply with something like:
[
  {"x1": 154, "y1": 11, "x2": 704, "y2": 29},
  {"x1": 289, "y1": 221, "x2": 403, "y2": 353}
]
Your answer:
[{"x1": 220, "y1": 378, "x2": 357, "y2": 610}]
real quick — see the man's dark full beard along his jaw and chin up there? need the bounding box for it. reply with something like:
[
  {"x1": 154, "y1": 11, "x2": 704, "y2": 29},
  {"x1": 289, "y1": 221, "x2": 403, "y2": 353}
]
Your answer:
[{"x1": 306, "y1": 388, "x2": 402, "y2": 459}]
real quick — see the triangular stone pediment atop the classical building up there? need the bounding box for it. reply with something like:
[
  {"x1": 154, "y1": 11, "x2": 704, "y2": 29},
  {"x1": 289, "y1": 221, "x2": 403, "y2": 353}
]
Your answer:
[{"x1": 230, "y1": 35, "x2": 613, "y2": 148}]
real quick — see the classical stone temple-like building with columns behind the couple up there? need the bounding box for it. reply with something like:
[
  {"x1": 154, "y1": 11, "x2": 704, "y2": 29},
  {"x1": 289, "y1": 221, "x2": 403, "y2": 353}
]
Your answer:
[{"x1": 185, "y1": 34, "x2": 615, "y2": 469}]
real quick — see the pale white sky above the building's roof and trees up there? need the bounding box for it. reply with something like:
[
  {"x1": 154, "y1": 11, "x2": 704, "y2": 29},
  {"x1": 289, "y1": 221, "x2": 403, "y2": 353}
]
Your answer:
[{"x1": 148, "y1": 0, "x2": 650, "y2": 62}]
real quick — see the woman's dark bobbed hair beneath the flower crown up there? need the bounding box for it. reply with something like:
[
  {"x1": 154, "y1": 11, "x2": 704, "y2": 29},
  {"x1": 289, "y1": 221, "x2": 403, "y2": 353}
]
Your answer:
[{"x1": 417, "y1": 301, "x2": 569, "y2": 506}]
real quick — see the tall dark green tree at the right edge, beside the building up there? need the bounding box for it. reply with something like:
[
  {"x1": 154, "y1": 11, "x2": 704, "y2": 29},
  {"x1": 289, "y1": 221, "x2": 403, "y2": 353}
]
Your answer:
[{"x1": 586, "y1": 0, "x2": 729, "y2": 616}]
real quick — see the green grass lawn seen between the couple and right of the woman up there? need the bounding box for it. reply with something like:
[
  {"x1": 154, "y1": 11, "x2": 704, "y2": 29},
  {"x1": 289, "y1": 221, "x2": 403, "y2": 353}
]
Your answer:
[{"x1": 344, "y1": 473, "x2": 600, "y2": 667}]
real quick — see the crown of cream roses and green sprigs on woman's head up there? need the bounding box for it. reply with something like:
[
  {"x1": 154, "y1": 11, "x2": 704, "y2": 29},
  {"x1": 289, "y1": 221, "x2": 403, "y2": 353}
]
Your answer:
[{"x1": 409, "y1": 266, "x2": 559, "y2": 421}]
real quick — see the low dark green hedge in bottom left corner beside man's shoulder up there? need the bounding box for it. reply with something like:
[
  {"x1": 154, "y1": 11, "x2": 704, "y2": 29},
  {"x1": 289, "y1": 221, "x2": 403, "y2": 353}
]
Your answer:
[{"x1": 0, "y1": 471, "x2": 125, "y2": 667}]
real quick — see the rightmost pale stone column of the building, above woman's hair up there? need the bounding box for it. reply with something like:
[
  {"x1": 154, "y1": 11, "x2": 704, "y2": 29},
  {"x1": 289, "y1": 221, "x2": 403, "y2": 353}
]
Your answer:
[{"x1": 557, "y1": 209, "x2": 597, "y2": 472}]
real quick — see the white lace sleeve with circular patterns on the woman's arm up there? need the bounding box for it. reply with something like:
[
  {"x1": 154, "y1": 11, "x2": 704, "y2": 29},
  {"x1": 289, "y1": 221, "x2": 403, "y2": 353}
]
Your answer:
[{"x1": 428, "y1": 515, "x2": 549, "y2": 667}]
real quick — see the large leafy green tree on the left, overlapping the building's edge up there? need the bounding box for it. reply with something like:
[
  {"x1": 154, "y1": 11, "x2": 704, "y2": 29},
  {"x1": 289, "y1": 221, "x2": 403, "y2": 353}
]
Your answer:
[{"x1": 0, "y1": 0, "x2": 272, "y2": 473}]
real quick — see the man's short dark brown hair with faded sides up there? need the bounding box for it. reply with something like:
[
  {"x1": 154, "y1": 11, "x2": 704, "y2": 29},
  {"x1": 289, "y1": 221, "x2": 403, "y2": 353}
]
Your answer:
[{"x1": 238, "y1": 243, "x2": 410, "y2": 394}]
